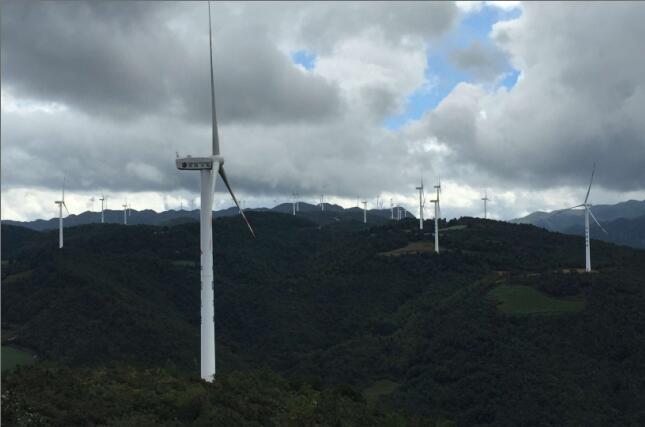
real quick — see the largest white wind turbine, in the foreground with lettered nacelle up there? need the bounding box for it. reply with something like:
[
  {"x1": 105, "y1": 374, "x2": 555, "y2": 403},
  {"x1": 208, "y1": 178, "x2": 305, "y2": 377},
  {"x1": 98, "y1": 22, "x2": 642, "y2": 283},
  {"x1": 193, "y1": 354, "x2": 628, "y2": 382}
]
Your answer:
[{"x1": 175, "y1": 2, "x2": 255, "y2": 382}]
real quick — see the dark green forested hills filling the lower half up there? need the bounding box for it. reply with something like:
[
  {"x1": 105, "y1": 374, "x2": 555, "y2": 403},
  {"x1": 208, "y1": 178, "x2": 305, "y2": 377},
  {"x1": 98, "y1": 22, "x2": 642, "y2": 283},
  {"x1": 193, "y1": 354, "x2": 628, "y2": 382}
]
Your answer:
[{"x1": 2, "y1": 212, "x2": 645, "y2": 426}]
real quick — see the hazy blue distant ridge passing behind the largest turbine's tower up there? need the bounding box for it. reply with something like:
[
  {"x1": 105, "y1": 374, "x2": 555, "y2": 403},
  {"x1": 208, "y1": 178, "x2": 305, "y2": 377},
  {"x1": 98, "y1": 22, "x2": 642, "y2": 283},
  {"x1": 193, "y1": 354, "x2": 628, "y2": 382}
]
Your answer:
[{"x1": 2, "y1": 202, "x2": 414, "y2": 231}]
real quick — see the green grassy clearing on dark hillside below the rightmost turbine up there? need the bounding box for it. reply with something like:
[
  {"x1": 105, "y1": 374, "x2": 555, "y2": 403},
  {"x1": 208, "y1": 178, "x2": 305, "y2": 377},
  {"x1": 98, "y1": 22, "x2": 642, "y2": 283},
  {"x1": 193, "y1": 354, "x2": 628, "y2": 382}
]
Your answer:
[{"x1": 488, "y1": 285, "x2": 585, "y2": 315}]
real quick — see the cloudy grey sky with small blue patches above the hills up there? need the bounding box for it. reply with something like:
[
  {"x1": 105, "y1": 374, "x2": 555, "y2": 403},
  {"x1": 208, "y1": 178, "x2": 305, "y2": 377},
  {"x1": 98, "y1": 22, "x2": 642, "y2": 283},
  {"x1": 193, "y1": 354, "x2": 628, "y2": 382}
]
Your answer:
[{"x1": 0, "y1": 0, "x2": 645, "y2": 220}]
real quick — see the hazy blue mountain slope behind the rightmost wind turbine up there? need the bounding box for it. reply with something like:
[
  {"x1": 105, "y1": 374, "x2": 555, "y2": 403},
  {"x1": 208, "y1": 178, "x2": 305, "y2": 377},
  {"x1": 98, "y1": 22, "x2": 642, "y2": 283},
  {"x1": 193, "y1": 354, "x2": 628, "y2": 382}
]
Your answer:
[{"x1": 510, "y1": 200, "x2": 645, "y2": 249}]
